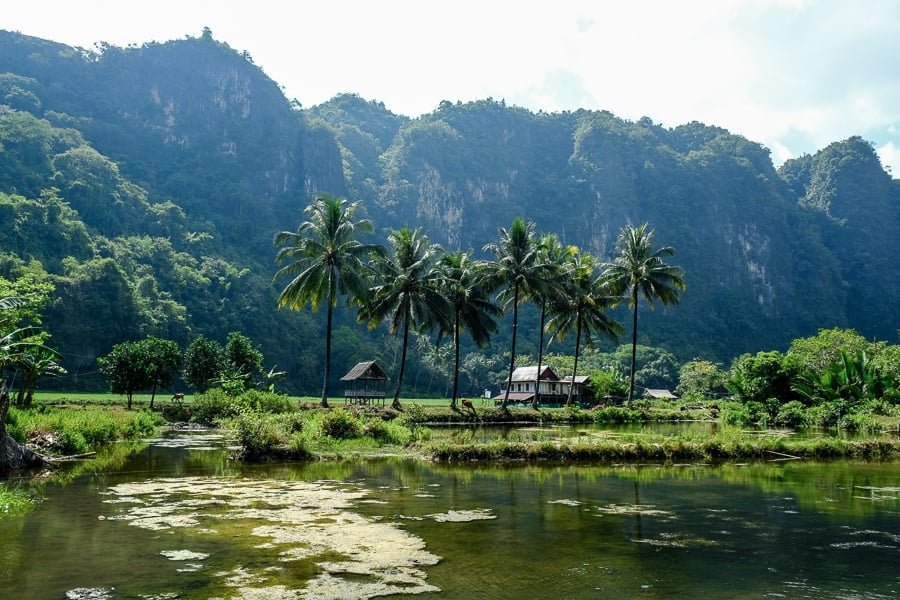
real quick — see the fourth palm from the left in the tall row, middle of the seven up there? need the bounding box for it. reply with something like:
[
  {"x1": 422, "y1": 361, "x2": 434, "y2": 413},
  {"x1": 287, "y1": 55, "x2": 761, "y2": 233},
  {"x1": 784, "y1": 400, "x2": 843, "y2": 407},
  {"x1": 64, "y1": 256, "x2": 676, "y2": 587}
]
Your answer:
[{"x1": 484, "y1": 217, "x2": 542, "y2": 410}]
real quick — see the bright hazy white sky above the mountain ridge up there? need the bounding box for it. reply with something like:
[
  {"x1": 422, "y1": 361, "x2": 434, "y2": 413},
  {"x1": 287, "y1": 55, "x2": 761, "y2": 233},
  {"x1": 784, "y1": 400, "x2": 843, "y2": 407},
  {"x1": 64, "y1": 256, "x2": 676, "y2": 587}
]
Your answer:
[{"x1": 0, "y1": 0, "x2": 900, "y2": 177}]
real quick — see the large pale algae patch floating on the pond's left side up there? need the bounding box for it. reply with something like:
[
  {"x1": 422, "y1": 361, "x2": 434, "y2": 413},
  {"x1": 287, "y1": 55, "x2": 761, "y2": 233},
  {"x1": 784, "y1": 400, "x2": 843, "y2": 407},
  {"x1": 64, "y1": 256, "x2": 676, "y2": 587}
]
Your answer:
[{"x1": 105, "y1": 477, "x2": 440, "y2": 599}]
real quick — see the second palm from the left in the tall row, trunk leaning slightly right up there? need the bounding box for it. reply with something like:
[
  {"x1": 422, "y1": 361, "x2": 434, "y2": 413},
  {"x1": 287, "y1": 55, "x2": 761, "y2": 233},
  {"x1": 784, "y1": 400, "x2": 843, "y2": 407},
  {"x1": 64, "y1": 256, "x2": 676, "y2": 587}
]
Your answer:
[{"x1": 360, "y1": 227, "x2": 451, "y2": 410}]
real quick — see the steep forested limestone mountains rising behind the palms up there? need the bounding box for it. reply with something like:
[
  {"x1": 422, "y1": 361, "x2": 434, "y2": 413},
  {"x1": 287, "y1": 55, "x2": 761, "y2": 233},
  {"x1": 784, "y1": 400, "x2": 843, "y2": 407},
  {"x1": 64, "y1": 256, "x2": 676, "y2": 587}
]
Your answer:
[{"x1": 0, "y1": 31, "x2": 900, "y2": 392}]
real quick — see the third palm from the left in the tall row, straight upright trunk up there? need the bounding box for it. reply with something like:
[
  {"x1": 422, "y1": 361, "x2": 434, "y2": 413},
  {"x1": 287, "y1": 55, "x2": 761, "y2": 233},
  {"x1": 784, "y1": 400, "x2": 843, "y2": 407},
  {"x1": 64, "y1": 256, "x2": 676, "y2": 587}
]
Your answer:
[{"x1": 438, "y1": 252, "x2": 500, "y2": 409}]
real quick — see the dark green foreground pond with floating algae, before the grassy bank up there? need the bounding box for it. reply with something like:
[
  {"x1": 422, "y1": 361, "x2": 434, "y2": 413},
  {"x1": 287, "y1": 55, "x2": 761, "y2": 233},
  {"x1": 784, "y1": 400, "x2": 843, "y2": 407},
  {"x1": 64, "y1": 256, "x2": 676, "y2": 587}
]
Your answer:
[{"x1": 0, "y1": 432, "x2": 900, "y2": 599}]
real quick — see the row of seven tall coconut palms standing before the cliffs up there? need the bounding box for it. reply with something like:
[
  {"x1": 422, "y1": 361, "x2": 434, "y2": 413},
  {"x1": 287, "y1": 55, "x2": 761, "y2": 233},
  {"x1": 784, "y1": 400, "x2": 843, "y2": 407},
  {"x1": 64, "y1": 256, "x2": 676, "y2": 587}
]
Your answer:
[{"x1": 275, "y1": 195, "x2": 684, "y2": 409}]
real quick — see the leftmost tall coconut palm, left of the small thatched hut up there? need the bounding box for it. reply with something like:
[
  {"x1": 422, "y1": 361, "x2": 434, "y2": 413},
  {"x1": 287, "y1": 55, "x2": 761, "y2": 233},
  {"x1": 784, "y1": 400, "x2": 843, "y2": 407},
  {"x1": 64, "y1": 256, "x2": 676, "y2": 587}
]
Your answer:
[{"x1": 275, "y1": 195, "x2": 384, "y2": 407}]
